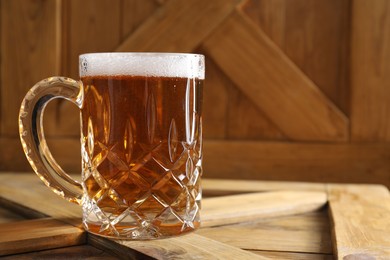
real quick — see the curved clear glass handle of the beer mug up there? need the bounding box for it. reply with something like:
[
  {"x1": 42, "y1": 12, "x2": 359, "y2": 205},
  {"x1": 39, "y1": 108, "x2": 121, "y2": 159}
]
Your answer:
[{"x1": 19, "y1": 77, "x2": 84, "y2": 205}]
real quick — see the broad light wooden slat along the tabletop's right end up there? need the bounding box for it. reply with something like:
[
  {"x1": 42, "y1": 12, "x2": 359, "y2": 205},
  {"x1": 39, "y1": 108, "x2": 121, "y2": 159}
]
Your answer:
[{"x1": 328, "y1": 185, "x2": 390, "y2": 259}]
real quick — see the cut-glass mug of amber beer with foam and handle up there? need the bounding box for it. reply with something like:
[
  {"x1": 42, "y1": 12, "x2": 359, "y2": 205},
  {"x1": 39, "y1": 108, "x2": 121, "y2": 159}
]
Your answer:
[{"x1": 19, "y1": 53, "x2": 205, "y2": 239}]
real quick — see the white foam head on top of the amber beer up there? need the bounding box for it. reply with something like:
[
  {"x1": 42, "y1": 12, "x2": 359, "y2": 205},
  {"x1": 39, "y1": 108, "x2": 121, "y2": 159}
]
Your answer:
[{"x1": 79, "y1": 52, "x2": 205, "y2": 79}]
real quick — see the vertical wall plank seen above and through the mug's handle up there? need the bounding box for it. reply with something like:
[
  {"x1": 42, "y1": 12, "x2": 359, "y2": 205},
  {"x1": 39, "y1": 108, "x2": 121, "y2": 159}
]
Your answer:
[{"x1": 44, "y1": 0, "x2": 122, "y2": 140}]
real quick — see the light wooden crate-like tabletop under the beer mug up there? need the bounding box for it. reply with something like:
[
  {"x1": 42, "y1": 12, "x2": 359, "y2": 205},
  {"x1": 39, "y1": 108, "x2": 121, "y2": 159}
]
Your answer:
[{"x1": 0, "y1": 172, "x2": 390, "y2": 260}]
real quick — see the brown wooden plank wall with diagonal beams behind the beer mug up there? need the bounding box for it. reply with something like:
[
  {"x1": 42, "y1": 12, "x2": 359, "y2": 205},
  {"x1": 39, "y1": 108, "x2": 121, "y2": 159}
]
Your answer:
[{"x1": 0, "y1": 0, "x2": 390, "y2": 186}]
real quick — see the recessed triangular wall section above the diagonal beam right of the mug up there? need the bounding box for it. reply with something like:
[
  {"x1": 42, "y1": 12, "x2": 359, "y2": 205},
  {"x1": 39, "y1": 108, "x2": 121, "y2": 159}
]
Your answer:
[{"x1": 243, "y1": 0, "x2": 351, "y2": 114}]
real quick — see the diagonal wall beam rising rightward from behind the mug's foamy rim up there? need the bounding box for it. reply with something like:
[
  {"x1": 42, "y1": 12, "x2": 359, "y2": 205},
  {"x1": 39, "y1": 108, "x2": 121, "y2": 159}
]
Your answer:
[{"x1": 116, "y1": 0, "x2": 239, "y2": 52}]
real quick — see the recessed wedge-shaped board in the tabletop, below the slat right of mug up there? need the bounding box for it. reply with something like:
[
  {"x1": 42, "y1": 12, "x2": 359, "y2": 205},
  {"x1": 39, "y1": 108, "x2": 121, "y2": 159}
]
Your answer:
[{"x1": 197, "y1": 209, "x2": 332, "y2": 254}]
